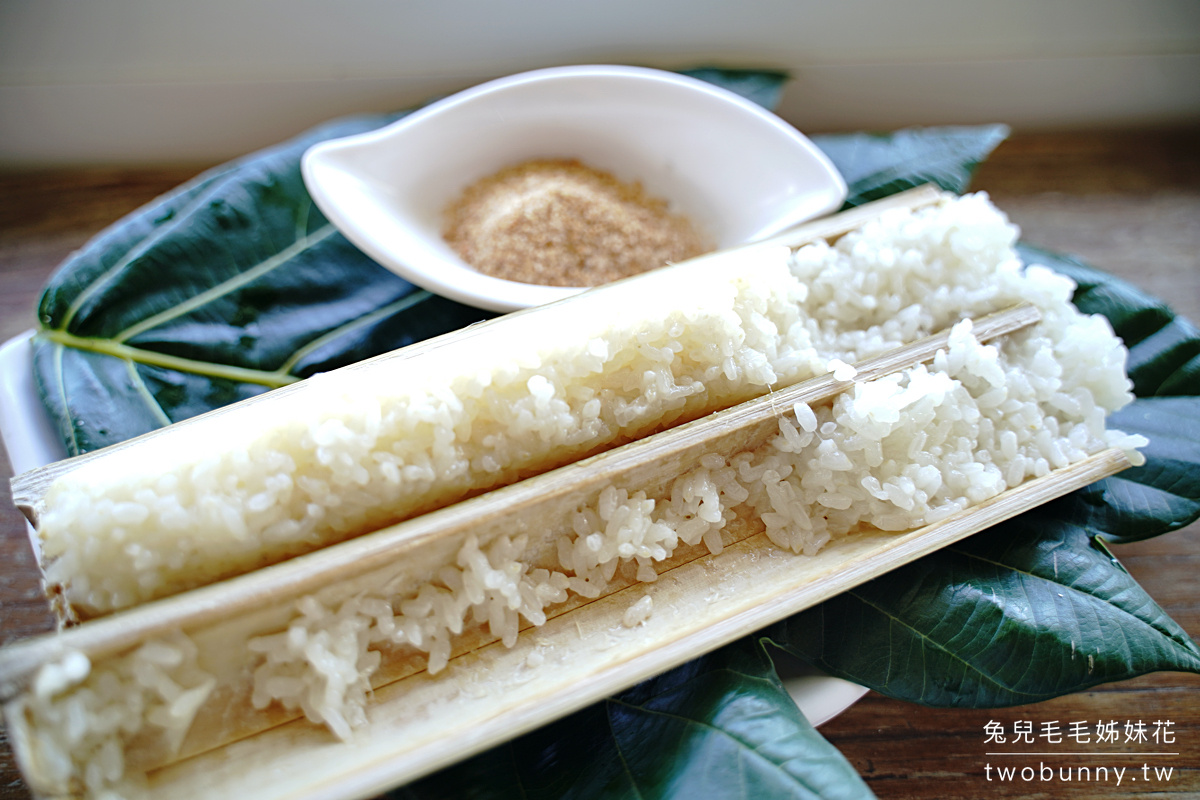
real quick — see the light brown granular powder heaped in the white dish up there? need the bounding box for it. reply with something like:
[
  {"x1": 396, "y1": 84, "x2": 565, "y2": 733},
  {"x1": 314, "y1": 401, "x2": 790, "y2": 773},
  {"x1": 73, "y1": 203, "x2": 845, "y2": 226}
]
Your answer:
[{"x1": 443, "y1": 160, "x2": 712, "y2": 287}]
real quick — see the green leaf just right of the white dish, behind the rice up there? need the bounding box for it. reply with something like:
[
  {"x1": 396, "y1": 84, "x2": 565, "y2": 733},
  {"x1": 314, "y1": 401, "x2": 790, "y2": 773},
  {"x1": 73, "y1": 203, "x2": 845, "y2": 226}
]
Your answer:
[{"x1": 812, "y1": 125, "x2": 1008, "y2": 207}]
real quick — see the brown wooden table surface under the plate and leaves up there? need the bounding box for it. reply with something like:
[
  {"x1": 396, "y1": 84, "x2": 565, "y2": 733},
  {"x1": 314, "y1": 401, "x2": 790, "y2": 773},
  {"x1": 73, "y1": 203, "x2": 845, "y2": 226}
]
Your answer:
[{"x1": 0, "y1": 128, "x2": 1200, "y2": 800}]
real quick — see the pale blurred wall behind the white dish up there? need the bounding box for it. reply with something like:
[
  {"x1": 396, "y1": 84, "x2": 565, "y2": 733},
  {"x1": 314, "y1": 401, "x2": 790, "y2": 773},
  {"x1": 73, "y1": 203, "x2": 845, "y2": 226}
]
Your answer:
[{"x1": 0, "y1": 0, "x2": 1200, "y2": 166}]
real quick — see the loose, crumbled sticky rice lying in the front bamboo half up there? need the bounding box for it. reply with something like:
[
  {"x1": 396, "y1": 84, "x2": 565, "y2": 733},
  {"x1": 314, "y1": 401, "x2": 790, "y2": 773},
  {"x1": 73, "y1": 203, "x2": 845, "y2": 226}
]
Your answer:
[{"x1": 8, "y1": 320, "x2": 1142, "y2": 798}]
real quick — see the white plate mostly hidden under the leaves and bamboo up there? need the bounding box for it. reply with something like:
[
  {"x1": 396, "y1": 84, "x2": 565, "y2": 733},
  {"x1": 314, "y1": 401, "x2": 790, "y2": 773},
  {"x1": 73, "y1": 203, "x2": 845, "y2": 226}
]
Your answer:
[{"x1": 0, "y1": 331, "x2": 866, "y2": 726}]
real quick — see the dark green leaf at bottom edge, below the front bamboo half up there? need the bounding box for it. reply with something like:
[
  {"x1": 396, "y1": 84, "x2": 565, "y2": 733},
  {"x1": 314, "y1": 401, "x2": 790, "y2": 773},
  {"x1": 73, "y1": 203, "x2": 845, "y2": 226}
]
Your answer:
[{"x1": 388, "y1": 638, "x2": 874, "y2": 800}]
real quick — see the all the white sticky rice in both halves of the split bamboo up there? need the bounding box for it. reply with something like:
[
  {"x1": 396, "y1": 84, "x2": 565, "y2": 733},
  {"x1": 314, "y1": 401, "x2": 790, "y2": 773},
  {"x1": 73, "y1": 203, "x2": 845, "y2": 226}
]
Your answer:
[{"x1": 8, "y1": 194, "x2": 1145, "y2": 796}]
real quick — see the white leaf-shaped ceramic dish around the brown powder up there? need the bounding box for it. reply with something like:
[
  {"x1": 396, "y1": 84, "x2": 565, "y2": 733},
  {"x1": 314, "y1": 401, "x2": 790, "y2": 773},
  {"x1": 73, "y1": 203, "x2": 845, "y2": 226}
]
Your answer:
[{"x1": 301, "y1": 66, "x2": 846, "y2": 311}]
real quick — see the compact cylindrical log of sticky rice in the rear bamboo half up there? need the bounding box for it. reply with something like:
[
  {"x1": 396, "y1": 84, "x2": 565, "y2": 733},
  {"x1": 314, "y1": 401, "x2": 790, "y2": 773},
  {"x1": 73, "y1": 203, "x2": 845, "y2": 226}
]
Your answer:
[{"x1": 30, "y1": 194, "x2": 1132, "y2": 618}]
